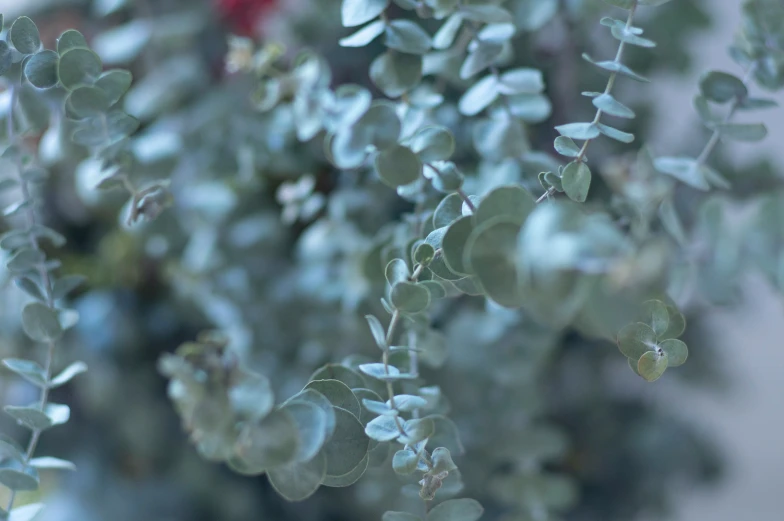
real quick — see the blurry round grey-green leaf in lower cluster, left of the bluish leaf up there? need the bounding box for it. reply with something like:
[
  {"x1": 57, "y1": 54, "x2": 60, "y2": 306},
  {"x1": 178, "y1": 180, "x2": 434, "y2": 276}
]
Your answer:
[{"x1": 235, "y1": 409, "x2": 300, "y2": 469}]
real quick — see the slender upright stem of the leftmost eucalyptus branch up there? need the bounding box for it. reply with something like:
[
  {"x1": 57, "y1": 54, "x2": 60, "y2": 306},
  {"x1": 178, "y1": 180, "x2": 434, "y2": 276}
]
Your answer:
[{"x1": 6, "y1": 85, "x2": 57, "y2": 512}]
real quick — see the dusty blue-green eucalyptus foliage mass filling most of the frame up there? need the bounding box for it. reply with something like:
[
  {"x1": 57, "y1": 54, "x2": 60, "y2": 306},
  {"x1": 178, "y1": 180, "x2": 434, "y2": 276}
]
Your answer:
[{"x1": 0, "y1": 0, "x2": 784, "y2": 521}]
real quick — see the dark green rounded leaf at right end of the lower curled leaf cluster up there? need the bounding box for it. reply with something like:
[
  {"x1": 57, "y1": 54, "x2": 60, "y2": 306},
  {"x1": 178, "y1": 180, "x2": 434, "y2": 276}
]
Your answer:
[{"x1": 322, "y1": 407, "x2": 370, "y2": 476}]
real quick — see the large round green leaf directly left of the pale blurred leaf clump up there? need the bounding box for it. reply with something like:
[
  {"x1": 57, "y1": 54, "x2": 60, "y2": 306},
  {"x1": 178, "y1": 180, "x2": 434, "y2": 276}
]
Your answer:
[{"x1": 463, "y1": 216, "x2": 522, "y2": 308}]
